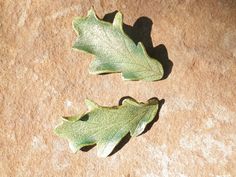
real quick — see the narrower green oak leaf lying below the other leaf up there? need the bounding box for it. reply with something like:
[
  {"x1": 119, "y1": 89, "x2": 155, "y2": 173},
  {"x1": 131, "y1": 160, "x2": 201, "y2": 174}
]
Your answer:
[{"x1": 54, "y1": 98, "x2": 159, "y2": 157}]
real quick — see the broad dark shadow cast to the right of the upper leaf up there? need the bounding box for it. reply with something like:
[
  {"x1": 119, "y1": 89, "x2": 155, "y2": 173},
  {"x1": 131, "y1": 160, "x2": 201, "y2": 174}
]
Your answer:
[{"x1": 103, "y1": 11, "x2": 173, "y2": 80}]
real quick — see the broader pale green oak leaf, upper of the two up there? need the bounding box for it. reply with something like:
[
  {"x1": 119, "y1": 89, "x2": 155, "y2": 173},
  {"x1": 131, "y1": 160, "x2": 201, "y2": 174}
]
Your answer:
[{"x1": 73, "y1": 9, "x2": 163, "y2": 81}]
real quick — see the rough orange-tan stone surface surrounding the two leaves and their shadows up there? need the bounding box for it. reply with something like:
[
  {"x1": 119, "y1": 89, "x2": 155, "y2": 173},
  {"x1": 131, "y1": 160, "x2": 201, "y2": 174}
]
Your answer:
[{"x1": 0, "y1": 0, "x2": 236, "y2": 177}]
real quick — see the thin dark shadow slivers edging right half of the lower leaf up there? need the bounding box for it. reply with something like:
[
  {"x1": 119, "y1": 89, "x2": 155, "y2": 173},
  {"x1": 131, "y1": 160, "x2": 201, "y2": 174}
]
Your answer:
[{"x1": 109, "y1": 96, "x2": 165, "y2": 156}]
